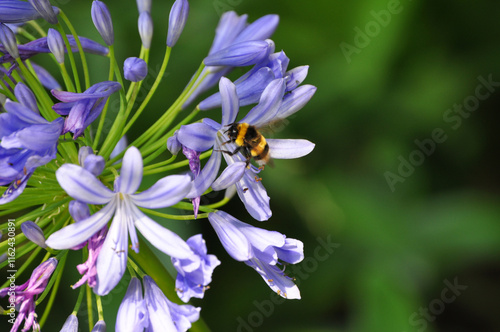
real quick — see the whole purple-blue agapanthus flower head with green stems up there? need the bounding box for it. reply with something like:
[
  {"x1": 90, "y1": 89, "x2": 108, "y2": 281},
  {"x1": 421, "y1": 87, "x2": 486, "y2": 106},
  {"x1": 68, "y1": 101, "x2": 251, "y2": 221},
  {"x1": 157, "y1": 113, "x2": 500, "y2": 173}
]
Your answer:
[{"x1": 0, "y1": 0, "x2": 316, "y2": 332}]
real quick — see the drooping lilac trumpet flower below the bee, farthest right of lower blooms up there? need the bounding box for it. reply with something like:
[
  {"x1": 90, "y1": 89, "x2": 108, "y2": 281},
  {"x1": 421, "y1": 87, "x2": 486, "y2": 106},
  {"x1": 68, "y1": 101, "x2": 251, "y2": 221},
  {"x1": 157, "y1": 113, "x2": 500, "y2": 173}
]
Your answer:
[{"x1": 208, "y1": 211, "x2": 304, "y2": 299}]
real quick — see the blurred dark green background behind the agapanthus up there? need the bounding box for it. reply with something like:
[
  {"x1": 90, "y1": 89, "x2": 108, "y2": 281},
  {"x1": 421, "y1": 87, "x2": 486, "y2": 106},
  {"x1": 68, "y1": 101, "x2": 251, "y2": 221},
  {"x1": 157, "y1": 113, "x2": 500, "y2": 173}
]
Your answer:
[{"x1": 20, "y1": 0, "x2": 500, "y2": 332}]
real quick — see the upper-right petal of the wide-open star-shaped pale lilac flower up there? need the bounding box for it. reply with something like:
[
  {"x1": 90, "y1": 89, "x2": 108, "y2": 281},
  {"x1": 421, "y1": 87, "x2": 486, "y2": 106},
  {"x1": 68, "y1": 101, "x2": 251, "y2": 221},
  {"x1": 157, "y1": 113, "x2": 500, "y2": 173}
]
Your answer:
[{"x1": 130, "y1": 175, "x2": 191, "y2": 209}]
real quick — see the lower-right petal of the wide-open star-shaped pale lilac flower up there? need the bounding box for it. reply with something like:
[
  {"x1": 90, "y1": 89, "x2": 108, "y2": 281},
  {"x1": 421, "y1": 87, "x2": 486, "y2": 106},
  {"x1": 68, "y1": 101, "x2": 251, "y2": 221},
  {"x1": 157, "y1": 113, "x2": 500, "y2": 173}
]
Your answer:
[{"x1": 132, "y1": 206, "x2": 194, "y2": 259}]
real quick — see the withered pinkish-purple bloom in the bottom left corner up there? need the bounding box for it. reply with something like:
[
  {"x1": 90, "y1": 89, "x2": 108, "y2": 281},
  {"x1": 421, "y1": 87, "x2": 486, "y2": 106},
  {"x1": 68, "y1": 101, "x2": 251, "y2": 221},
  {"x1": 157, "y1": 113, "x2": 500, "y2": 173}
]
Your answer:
[{"x1": 0, "y1": 257, "x2": 57, "y2": 331}]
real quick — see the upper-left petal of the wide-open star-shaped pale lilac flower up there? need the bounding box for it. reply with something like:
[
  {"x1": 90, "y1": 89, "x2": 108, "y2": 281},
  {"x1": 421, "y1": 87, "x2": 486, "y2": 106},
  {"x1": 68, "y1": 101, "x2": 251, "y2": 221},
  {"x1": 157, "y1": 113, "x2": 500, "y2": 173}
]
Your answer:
[{"x1": 56, "y1": 164, "x2": 114, "y2": 204}]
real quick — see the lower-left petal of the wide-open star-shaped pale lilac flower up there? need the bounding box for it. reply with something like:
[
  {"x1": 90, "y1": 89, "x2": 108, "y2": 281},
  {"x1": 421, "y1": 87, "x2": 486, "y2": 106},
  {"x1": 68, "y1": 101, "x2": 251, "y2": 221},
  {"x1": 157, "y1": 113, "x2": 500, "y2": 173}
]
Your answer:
[{"x1": 45, "y1": 200, "x2": 116, "y2": 249}]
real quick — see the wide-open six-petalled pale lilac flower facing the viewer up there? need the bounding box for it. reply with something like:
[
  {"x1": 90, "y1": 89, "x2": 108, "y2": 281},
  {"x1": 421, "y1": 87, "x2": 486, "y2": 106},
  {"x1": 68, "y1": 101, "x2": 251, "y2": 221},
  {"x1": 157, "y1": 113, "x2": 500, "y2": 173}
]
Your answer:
[{"x1": 46, "y1": 147, "x2": 194, "y2": 295}]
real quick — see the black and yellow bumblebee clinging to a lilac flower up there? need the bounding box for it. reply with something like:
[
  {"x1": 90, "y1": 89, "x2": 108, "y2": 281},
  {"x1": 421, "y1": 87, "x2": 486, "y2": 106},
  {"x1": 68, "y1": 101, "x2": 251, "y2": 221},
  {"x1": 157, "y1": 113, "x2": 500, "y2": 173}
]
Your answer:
[{"x1": 223, "y1": 122, "x2": 272, "y2": 166}]
